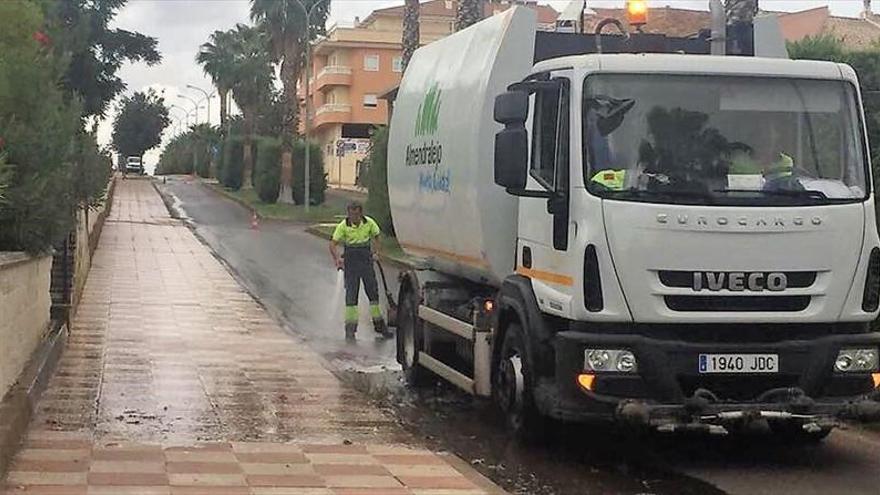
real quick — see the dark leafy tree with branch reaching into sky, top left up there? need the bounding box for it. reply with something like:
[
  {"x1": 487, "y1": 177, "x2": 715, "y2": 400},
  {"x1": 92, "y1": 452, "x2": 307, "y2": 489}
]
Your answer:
[{"x1": 43, "y1": 0, "x2": 162, "y2": 117}]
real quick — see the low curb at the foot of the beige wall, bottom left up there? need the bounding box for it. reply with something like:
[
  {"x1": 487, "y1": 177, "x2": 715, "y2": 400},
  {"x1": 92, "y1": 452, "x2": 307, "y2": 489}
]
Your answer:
[{"x1": 0, "y1": 325, "x2": 69, "y2": 479}]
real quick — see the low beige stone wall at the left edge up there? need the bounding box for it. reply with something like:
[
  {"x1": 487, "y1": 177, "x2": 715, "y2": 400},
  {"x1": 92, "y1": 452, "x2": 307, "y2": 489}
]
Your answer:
[{"x1": 0, "y1": 252, "x2": 52, "y2": 398}]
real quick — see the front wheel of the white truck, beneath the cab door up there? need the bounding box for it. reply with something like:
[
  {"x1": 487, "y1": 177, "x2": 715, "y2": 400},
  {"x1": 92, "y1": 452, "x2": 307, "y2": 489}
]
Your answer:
[{"x1": 492, "y1": 323, "x2": 544, "y2": 440}]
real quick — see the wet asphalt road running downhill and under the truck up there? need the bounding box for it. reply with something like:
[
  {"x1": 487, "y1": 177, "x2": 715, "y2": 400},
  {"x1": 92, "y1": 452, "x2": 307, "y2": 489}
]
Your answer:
[{"x1": 160, "y1": 178, "x2": 880, "y2": 495}]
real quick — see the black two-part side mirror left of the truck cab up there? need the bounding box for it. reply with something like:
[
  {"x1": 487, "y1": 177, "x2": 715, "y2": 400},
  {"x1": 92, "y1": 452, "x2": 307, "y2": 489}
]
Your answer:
[{"x1": 495, "y1": 91, "x2": 529, "y2": 189}]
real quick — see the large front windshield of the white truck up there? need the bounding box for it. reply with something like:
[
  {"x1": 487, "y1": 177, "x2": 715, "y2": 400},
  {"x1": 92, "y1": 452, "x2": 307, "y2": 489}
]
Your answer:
[{"x1": 583, "y1": 74, "x2": 868, "y2": 205}]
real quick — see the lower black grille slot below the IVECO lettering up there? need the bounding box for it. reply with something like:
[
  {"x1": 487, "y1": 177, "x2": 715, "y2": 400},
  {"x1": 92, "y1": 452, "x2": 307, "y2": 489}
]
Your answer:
[{"x1": 663, "y1": 296, "x2": 810, "y2": 313}]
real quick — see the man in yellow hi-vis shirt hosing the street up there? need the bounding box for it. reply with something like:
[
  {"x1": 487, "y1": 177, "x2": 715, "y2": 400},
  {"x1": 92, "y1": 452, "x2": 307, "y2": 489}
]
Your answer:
[{"x1": 330, "y1": 201, "x2": 390, "y2": 341}]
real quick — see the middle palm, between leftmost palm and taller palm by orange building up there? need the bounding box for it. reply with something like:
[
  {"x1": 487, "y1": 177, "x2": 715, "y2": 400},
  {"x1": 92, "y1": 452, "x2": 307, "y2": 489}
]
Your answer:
[{"x1": 228, "y1": 24, "x2": 273, "y2": 188}]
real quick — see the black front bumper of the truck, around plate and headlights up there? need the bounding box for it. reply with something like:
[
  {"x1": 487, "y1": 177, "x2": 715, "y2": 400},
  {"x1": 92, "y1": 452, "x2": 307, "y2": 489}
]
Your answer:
[{"x1": 535, "y1": 331, "x2": 880, "y2": 429}]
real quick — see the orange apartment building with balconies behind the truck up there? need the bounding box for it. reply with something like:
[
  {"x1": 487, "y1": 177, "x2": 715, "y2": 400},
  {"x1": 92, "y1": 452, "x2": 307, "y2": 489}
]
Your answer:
[{"x1": 299, "y1": 0, "x2": 558, "y2": 187}]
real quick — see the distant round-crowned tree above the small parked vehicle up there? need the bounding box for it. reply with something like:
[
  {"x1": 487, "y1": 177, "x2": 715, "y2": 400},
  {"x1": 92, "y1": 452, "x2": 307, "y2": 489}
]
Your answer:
[{"x1": 113, "y1": 89, "x2": 171, "y2": 157}]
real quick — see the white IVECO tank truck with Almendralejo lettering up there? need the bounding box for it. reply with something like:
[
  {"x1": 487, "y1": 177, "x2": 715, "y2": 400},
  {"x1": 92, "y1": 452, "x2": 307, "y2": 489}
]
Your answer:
[{"x1": 389, "y1": 8, "x2": 880, "y2": 440}]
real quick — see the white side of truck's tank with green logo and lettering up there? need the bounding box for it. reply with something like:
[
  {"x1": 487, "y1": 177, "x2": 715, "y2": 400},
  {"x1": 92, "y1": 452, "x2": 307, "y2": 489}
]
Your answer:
[{"x1": 388, "y1": 8, "x2": 536, "y2": 283}]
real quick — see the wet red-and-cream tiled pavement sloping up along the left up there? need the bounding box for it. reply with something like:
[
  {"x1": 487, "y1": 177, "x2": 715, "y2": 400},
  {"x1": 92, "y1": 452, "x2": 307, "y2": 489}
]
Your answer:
[{"x1": 0, "y1": 180, "x2": 500, "y2": 495}]
